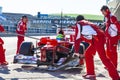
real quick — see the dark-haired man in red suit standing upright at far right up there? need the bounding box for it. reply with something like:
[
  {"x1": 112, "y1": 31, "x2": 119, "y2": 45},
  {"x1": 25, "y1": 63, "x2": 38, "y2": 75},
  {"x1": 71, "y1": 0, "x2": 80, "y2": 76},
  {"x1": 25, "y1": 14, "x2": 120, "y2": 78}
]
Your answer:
[{"x1": 101, "y1": 6, "x2": 120, "y2": 69}]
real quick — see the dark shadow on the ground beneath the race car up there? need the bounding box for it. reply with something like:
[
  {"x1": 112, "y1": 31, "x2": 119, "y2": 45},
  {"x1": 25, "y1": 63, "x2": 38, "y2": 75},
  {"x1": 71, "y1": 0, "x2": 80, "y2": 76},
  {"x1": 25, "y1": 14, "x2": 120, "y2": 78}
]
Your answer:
[{"x1": 14, "y1": 66, "x2": 82, "y2": 79}]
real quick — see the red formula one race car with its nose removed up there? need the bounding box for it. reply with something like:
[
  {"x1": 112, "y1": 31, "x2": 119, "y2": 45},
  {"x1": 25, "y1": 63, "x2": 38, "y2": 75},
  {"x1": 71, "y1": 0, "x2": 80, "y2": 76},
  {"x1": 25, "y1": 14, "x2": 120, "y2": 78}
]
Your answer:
[{"x1": 14, "y1": 37, "x2": 89, "y2": 71}]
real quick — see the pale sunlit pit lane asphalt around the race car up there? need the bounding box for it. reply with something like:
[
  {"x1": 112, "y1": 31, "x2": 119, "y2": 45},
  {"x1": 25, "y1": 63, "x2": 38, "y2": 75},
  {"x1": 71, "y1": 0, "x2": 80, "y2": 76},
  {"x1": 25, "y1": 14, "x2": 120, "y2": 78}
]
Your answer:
[{"x1": 0, "y1": 36, "x2": 120, "y2": 80}]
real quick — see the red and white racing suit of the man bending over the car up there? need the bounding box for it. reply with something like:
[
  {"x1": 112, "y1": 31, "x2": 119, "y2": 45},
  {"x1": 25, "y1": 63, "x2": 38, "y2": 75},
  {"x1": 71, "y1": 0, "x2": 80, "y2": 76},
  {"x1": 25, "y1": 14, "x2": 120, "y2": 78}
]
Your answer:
[{"x1": 75, "y1": 20, "x2": 119, "y2": 80}]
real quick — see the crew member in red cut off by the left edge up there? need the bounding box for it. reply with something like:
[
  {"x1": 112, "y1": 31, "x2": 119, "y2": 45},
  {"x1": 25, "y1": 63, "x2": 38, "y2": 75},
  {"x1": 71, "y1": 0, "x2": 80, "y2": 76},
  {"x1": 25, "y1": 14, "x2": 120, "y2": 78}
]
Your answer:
[{"x1": 0, "y1": 25, "x2": 8, "y2": 65}]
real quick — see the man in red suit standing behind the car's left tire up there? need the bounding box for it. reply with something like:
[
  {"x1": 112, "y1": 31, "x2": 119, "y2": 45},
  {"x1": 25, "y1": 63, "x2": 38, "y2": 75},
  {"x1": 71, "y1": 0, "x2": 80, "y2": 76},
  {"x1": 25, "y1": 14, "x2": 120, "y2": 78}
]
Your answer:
[{"x1": 16, "y1": 16, "x2": 28, "y2": 54}]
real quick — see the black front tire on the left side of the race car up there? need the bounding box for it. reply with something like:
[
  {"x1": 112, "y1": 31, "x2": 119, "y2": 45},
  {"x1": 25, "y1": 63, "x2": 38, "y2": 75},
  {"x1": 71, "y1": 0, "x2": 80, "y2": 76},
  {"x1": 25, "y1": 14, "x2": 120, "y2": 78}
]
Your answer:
[{"x1": 19, "y1": 42, "x2": 34, "y2": 56}]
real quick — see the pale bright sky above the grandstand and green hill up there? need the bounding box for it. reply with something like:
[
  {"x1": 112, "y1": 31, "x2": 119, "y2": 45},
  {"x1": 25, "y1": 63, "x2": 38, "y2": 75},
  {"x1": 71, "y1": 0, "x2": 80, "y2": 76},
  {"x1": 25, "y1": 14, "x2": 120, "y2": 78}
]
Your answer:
[{"x1": 0, "y1": 0, "x2": 106, "y2": 15}]
